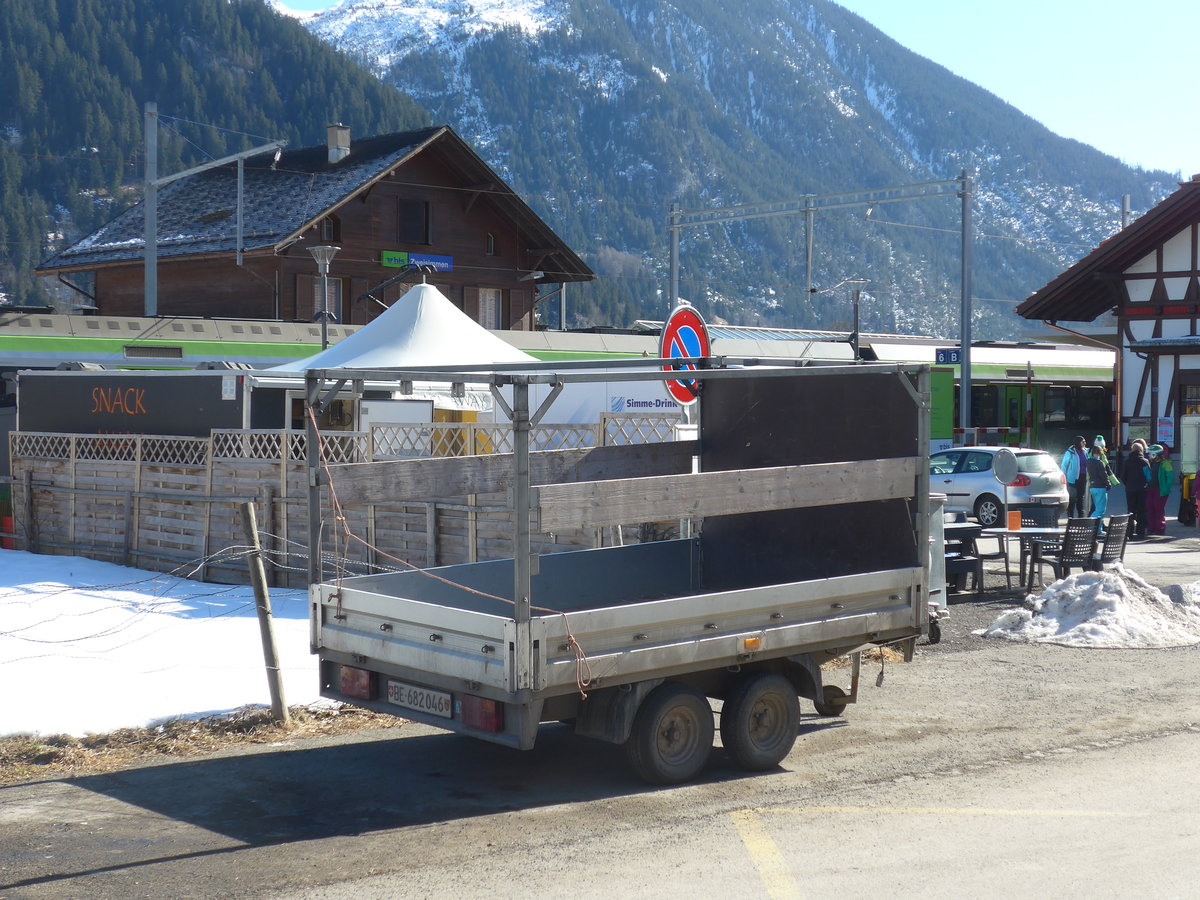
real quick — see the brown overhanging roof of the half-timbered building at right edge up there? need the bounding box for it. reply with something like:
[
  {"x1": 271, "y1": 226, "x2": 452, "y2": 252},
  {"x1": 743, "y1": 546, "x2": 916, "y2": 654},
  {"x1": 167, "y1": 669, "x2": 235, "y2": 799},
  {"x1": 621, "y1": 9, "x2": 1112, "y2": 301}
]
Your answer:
[{"x1": 1016, "y1": 175, "x2": 1200, "y2": 322}]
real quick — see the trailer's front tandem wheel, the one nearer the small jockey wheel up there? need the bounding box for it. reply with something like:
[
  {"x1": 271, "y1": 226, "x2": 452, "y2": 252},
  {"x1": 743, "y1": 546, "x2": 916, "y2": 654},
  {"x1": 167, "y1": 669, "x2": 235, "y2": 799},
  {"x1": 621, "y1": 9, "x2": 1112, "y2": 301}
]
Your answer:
[{"x1": 721, "y1": 672, "x2": 800, "y2": 772}]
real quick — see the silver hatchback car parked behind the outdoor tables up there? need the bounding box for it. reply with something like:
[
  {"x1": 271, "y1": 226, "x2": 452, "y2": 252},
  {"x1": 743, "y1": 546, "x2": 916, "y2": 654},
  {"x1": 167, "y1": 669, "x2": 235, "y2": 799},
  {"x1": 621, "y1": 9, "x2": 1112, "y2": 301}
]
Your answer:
[{"x1": 929, "y1": 446, "x2": 1067, "y2": 528}]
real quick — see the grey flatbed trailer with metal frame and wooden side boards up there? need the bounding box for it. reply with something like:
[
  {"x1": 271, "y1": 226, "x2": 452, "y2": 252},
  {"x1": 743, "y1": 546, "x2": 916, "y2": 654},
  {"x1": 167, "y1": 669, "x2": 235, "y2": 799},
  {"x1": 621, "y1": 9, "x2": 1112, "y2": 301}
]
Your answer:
[{"x1": 307, "y1": 358, "x2": 930, "y2": 784}]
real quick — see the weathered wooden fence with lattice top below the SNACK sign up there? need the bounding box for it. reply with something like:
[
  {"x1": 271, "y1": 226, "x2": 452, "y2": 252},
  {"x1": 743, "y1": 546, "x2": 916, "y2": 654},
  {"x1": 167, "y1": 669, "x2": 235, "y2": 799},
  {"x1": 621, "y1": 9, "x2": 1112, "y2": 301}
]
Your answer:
[{"x1": 10, "y1": 415, "x2": 678, "y2": 587}]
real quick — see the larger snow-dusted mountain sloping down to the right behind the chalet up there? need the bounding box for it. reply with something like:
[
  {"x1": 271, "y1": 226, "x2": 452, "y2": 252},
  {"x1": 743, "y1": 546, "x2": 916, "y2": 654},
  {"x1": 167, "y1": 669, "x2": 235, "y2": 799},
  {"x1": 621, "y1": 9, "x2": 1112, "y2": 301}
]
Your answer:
[{"x1": 297, "y1": 0, "x2": 1175, "y2": 338}]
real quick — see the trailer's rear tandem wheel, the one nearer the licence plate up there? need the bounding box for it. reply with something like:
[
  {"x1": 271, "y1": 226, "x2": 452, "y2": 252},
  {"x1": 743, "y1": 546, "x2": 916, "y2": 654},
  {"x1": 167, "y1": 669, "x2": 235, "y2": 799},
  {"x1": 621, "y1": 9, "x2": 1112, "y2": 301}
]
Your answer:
[{"x1": 625, "y1": 682, "x2": 714, "y2": 785}]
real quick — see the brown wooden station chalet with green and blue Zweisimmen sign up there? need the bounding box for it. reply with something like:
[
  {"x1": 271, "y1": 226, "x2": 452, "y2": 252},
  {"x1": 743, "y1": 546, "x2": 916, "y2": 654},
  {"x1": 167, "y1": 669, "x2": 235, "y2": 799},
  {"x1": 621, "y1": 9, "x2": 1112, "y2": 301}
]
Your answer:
[{"x1": 37, "y1": 125, "x2": 595, "y2": 330}]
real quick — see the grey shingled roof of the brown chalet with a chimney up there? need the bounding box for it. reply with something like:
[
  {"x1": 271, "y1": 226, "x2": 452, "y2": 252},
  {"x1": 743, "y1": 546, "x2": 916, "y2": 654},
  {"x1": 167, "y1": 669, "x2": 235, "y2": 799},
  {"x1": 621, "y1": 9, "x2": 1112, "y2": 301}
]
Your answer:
[{"x1": 36, "y1": 125, "x2": 594, "y2": 281}]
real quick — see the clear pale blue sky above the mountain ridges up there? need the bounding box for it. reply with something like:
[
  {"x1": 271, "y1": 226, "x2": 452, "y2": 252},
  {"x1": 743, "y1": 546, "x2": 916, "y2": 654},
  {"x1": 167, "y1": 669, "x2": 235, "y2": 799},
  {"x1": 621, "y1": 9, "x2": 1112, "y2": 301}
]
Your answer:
[{"x1": 274, "y1": 0, "x2": 1200, "y2": 179}]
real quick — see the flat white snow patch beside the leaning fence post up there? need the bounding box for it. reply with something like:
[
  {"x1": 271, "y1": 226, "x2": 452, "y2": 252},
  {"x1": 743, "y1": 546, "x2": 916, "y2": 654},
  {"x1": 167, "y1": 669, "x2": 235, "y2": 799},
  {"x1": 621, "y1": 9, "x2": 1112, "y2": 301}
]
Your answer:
[{"x1": 0, "y1": 550, "x2": 319, "y2": 737}]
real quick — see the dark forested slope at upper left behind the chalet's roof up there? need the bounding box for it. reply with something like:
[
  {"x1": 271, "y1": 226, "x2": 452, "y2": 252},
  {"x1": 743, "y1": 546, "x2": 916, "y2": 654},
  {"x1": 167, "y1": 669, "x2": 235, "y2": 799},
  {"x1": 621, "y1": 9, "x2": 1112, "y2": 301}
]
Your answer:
[{"x1": 0, "y1": 0, "x2": 430, "y2": 306}]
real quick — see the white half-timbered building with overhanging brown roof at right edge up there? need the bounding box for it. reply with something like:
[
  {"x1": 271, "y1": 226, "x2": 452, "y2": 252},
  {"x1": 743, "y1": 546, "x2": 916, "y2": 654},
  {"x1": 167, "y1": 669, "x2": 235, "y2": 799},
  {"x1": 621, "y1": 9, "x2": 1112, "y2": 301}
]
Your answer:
[{"x1": 1016, "y1": 175, "x2": 1200, "y2": 464}]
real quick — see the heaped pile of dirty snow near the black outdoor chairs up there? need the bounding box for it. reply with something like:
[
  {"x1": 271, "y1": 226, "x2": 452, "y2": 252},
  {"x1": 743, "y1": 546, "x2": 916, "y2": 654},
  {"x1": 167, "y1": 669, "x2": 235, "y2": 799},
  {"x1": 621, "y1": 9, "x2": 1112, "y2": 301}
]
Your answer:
[{"x1": 976, "y1": 563, "x2": 1200, "y2": 649}]
